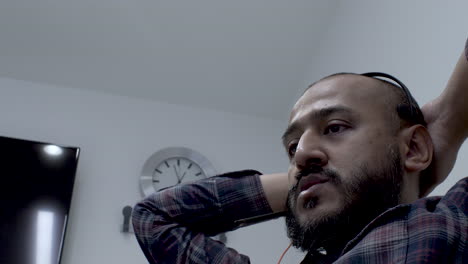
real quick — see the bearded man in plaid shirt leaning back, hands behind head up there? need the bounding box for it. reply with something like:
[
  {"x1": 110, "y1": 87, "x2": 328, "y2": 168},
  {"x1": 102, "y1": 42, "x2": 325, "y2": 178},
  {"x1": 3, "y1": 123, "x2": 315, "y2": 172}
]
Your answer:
[{"x1": 133, "y1": 42, "x2": 468, "y2": 263}]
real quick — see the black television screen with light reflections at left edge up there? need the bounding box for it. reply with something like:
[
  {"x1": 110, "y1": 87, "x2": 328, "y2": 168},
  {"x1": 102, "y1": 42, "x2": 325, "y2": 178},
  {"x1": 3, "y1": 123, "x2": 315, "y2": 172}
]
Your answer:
[{"x1": 0, "y1": 136, "x2": 80, "y2": 264}]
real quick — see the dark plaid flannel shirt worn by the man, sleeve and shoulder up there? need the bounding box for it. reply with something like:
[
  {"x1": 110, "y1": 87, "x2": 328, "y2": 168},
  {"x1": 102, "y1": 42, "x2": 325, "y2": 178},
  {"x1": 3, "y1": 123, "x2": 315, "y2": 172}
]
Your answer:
[{"x1": 133, "y1": 171, "x2": 468, "y2": 264}]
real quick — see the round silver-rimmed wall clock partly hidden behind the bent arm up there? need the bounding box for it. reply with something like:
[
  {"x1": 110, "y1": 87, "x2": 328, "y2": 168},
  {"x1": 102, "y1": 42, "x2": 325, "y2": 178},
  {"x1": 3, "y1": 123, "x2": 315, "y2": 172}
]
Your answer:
[{"x1": 140, "y1": 147, "x2": 227, "y2": 243}]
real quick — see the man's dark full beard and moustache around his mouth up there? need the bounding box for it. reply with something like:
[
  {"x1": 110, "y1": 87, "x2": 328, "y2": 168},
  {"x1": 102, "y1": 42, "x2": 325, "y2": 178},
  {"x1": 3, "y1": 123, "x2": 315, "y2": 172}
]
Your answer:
[{"x1": 286, "y1": 145, "x2": 403, "y2": 251}]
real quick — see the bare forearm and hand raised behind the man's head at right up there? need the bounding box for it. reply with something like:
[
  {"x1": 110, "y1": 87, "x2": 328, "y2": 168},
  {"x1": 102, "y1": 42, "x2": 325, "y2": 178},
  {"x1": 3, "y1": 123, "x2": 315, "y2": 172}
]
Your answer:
[{"x1": 421, "y1": 40, "x2": 468, "y2": 196}]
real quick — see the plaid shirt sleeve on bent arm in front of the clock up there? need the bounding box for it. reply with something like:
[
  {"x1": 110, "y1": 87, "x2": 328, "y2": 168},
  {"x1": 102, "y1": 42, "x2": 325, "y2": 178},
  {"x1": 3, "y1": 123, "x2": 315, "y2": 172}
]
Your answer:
[{"x1": 132, "y1": 171, "x2": 272, "y2": 264}]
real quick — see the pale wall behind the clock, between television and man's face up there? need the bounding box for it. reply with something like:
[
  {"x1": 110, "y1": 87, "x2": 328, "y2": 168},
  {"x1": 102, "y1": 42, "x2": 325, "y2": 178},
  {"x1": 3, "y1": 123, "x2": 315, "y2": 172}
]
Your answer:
[{"x1": 0, "y1": 78, "x2": 306, "y2": 264}]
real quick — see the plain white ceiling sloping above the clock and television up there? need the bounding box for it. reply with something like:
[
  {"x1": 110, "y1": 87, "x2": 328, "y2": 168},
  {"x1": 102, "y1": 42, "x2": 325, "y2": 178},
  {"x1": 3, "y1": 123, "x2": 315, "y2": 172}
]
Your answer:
[{"x1": 0, "y1": 0, "x2": 339, "y2": 120}]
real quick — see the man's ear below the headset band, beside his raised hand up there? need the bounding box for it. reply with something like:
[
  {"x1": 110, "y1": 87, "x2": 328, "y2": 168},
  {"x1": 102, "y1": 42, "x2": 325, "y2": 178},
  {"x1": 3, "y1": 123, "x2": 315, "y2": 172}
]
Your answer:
[{"x1": 401, "y1": 125, "x2": 433, "y2": 173}]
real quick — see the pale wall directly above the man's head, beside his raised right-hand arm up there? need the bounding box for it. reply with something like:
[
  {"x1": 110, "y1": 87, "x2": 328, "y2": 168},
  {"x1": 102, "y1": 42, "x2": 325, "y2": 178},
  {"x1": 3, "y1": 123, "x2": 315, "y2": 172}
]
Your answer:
[{"x1": 304, "y1": 0, "x2": 468, "y2": 195}]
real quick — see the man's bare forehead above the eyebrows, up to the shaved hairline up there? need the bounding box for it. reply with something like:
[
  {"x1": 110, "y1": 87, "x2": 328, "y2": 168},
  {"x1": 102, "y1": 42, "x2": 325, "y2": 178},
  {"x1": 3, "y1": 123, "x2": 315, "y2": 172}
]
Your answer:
[{"x1": 290, "y1": 74, "x2": 392, "y2": 123}]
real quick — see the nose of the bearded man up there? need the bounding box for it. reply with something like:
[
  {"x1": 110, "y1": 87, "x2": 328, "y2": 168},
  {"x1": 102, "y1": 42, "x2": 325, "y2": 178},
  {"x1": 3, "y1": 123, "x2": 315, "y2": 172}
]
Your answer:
[{"x1": 294, "y1": 131, "x2": 328, "y2": 171}]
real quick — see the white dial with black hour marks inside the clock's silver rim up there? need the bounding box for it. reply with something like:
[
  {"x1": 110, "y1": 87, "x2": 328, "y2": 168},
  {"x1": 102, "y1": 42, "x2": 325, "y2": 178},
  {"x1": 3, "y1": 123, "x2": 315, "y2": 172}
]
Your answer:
[{"x1": 152, "y1": 157, "x2": 206, "y2": 190}]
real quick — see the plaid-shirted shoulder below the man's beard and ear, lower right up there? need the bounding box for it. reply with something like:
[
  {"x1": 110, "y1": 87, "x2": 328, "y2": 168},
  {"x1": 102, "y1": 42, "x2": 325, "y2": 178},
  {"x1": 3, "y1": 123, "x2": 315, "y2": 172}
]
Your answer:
[{"x1": 336, "y1": 178, "x2": 468, "y2": 263}]
